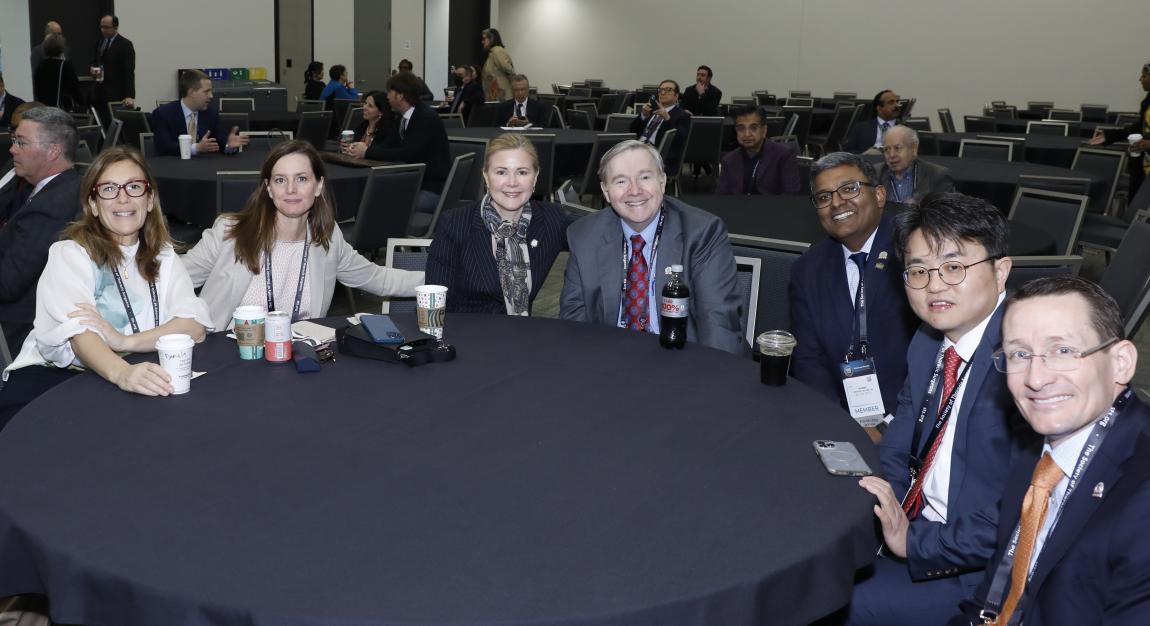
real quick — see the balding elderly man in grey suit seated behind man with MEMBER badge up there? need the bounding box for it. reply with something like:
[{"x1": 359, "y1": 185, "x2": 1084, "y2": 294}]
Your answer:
[{"x1": 875, "y1": 127, "x2": 955, "y2": 205}]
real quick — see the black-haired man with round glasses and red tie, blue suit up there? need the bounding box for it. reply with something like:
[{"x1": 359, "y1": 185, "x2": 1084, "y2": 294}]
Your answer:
[{"x1": 850, "y1": 193, "x2": 1033, "y2": 624}]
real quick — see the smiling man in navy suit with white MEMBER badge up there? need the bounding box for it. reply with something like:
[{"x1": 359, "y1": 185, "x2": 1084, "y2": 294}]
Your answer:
[{"x1": 791, "y1": 154, "x2": 918, "y2": 426}]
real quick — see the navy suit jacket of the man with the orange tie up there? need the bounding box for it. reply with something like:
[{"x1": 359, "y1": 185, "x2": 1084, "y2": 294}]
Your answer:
[{"x1": 951, "y1": 397, "x2": 1150, "y2": 626}]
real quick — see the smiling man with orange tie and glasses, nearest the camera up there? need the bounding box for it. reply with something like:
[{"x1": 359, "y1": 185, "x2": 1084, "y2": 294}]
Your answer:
[{"x1": 952, "y1": 276, "x2": 1150, "y2": 626}]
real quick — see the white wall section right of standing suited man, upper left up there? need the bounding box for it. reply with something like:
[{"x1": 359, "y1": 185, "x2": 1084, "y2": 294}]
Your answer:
[{"x1": 117, "y1": 0, "x2": 276, "y2": 110}]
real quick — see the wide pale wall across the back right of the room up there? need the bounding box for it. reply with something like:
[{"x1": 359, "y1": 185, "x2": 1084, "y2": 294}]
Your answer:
[{"x1": 501, "y1": 0, "x2": 1148, "y2": 128}]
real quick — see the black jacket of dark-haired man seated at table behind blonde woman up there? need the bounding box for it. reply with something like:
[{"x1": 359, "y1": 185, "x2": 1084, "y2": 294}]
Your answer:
[{"x1": 366, "y1": 104, "x2": 451, "y2": 193}]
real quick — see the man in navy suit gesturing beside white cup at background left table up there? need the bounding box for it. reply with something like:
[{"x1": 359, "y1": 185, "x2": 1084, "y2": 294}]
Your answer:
[{"x1": 152, "y1": 69, "x2": 247, "y2": 157}]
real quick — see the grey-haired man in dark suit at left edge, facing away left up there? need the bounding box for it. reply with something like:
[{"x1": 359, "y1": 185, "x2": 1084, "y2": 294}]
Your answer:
[{"x1": 0, "y1": 107, "x2": 81, "y2": 354}]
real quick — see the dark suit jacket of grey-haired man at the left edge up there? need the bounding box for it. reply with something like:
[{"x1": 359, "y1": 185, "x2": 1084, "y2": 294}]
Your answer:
[{"x1": 0, "y1": 169, "x2": 81, "y2": 356}]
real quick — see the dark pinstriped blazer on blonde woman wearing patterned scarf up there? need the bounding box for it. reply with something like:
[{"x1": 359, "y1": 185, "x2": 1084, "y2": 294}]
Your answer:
[{"x1": 427, "y1": 200, "x2": 569, "y2": 314}]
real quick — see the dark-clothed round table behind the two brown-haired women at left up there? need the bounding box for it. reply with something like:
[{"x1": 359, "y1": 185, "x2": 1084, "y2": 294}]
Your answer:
[{"x1": 147, "y1": 150, "x2": 371, "y2": 228}]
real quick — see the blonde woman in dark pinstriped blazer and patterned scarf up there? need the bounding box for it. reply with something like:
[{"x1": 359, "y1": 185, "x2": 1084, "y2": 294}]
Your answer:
[{"x1": 427, "y1": 132, "x2": 568, "y2": 315}]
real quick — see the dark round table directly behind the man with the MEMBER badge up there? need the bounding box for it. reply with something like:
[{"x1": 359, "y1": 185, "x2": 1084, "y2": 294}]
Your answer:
[{"x1": 680, "y1": 194, "x2": 1055, "y2": 255}]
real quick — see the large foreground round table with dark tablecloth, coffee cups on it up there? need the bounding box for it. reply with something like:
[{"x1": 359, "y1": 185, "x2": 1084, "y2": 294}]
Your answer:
[{"x1": 0, "y1": 314, "x2": 877, "y2": 626}]
